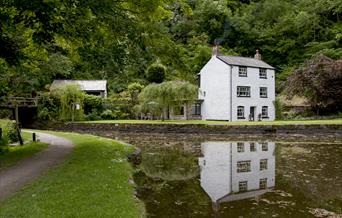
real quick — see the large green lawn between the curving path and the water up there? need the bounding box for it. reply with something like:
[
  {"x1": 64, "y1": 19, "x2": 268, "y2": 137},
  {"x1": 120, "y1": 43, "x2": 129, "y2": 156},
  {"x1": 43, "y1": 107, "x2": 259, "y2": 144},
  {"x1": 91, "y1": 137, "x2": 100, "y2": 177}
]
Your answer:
[{"x1": 0, "y1": 133, "x2": 144, "y2": 218}]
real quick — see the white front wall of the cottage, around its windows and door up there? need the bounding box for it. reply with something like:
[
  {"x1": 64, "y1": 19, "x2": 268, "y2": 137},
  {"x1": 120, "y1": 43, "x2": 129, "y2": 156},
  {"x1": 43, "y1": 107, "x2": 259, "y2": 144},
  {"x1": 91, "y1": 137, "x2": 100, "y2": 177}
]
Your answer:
[{"x1": 232, "y1": 66, "x2": 275, "y2": 121}]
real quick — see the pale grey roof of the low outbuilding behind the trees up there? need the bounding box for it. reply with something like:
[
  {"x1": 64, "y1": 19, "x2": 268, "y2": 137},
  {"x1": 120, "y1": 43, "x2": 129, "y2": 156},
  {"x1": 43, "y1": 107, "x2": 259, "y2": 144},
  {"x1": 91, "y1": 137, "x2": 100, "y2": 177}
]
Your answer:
[{"x1": 51, "y1": 80, "x2": 107, "y2": 91}]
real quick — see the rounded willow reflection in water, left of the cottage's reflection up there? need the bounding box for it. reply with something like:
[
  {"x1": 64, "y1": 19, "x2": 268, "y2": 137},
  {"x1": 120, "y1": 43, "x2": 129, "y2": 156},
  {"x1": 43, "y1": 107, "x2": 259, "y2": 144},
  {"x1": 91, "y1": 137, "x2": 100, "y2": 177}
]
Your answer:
[{"x1": 140, "y1": 147, "x2": 199, "y2": 181}]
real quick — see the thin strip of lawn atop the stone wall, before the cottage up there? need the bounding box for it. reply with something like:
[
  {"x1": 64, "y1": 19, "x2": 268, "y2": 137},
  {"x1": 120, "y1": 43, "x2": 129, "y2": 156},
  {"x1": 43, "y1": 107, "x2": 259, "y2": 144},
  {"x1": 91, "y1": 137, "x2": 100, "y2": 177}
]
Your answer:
[{"x1": 80, "y1": 119, "x2": 342, "y2": 125}]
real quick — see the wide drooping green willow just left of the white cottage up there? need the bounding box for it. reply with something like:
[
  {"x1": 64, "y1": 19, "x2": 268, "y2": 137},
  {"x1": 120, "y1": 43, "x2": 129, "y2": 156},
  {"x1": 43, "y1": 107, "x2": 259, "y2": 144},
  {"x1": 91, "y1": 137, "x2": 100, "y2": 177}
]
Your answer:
[{"x1": 139, "y1": 81, "x2": 198, "y2": 120}]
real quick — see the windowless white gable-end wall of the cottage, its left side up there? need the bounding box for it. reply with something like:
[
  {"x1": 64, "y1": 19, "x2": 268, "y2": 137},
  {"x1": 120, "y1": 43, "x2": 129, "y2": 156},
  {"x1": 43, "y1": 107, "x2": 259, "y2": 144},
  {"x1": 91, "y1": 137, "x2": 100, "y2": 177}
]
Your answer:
[{"x1": 199, "y1": 56, "x2": 230, "y2": 120}]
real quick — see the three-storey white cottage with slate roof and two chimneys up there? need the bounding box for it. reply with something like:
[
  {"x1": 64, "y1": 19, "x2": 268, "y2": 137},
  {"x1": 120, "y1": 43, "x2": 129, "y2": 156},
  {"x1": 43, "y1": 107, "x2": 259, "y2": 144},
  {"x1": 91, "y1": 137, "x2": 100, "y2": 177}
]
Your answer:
[{"x1": 198, "y1": 47, "x2": 275, "y2": 121}]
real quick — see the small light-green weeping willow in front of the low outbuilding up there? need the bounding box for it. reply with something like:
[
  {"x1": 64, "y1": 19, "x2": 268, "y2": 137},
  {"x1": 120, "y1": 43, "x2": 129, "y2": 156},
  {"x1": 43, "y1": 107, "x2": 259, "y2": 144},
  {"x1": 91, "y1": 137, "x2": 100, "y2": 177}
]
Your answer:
[{"x1": 53, "y1": 84, "x2": 84, "y2": 121}]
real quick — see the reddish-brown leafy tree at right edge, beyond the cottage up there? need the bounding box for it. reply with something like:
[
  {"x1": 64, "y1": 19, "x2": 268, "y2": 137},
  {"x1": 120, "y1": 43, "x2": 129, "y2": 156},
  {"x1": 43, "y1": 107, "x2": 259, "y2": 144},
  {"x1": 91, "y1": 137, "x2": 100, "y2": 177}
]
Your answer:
[{"x1": 287, "y1": 55, "x2": 342, "y2": 113}]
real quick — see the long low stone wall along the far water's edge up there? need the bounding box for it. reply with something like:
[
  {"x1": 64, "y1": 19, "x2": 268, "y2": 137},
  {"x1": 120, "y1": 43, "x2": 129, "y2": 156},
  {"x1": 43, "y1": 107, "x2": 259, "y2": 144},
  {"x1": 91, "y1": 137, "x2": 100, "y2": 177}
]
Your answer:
[{"x1": 42, "y1": 123, "x2": 342, "y2": 135}]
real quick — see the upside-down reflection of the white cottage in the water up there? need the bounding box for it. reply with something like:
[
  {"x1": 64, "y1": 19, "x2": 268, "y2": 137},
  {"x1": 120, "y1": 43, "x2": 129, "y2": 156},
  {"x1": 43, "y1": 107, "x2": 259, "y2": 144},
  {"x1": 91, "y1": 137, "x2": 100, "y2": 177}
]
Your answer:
[{"x1": 199, "y1": 142, "x2": 275, "y2": 203}]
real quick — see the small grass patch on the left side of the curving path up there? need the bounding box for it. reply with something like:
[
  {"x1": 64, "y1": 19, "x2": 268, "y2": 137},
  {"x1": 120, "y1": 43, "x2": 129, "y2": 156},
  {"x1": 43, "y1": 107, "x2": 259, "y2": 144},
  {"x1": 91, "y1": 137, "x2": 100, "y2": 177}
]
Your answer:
[{"x1": 0, "y1": 142, "x2": 48, "y2": 170}]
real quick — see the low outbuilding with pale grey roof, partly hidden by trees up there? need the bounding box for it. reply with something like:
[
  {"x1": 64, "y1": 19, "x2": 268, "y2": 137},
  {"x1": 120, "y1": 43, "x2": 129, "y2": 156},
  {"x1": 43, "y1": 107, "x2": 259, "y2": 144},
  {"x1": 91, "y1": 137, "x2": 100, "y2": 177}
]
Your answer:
[{"x1": 51, "y1": 80, "x2": 107, "y2": 98}]
